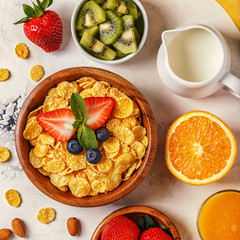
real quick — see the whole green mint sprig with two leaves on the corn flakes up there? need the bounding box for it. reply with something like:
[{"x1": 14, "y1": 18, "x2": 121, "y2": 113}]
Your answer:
[{"x1": 70, "y1": 93, "x2": 98, "y2": 151}]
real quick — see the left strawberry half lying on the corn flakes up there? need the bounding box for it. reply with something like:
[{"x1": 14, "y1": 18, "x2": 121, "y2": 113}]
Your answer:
[{"x1": 37, "y1": 109, "x2": 76, "y2": 142}]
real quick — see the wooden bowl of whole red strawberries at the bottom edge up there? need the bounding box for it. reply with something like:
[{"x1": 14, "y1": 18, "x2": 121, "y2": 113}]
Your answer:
[{"x1": 91, "y1": 206, "x2": 181, "y2": 240}]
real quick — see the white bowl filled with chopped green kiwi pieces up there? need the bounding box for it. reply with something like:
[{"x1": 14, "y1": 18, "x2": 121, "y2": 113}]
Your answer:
[{"x1": 71, "y1": 0, "x2": 148, "y2": 64}]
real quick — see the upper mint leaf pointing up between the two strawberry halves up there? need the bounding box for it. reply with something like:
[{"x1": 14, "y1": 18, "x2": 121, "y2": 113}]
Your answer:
[{"x1": 70, "y1": 93, "x2": 87, "y2": 121}]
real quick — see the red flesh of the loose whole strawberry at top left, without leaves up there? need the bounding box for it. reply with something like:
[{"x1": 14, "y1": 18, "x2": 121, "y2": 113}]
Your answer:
[{"x1": 23, "y1": 10, "x2": 63, "y2": 52}]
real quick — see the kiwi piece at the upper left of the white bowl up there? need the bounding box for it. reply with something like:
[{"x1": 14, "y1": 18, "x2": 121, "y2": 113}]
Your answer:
[{"x1": 76, "y1": 1, "x2": 106, "y2": 31}]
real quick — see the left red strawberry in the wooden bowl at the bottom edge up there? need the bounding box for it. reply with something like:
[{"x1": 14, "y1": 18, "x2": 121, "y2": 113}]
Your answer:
[{"x1": 101, "y1": 216, "x2": 140, "y2": 240}]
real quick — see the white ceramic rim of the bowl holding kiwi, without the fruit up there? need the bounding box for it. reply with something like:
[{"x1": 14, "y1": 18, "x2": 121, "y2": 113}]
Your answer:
[{"x1": 71, "y1": 0, "x2": 148, "y2": 64}]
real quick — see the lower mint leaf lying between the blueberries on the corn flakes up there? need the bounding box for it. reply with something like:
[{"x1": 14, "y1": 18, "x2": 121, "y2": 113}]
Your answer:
[{"x1": 78, "y1": 125, "x2": 98, "y2": 151}]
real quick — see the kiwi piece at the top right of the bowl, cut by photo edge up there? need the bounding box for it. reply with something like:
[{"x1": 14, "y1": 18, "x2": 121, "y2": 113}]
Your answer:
[{"x1": 107, "y1": 0, "x2": 138, "y2": 19}]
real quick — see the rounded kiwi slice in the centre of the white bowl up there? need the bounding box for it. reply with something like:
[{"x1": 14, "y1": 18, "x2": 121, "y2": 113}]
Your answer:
[{"x1": 99, "y1": 10, "x2": 123, "y2": 45}]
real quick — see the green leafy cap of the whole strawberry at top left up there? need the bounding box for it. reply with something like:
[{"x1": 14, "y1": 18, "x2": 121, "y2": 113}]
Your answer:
[{"x1": 14, "y1": 0, "x2": 53, "y2": 24}]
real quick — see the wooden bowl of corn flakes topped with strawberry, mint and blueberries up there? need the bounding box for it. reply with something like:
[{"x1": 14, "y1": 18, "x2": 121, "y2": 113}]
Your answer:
[{"x1": 15, "y1": 67, "x2": 157, "y2": 207}]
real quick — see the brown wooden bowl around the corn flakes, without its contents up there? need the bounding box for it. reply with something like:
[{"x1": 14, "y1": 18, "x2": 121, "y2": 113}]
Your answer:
[{"x1": 15, "y1": 67, "x2": 157, "y2": 207}]
